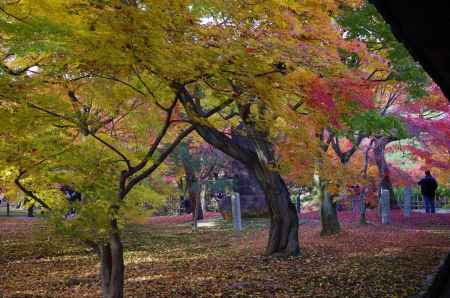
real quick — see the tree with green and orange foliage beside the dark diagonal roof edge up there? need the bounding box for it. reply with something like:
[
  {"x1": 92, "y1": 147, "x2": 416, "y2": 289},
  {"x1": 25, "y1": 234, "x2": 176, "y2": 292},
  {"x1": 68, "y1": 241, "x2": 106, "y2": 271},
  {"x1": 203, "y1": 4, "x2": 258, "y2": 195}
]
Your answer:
[{"x1": 335, "y1": 1, "x2": 444, "y2": 210}]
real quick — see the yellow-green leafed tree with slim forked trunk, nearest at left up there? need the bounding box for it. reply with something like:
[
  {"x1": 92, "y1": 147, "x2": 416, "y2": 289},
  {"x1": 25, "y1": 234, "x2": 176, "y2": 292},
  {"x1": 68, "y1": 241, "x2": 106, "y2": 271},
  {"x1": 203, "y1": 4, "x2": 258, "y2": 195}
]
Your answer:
[{"x1": 1, "y1": 1, "x2": 229, "y2": 297}]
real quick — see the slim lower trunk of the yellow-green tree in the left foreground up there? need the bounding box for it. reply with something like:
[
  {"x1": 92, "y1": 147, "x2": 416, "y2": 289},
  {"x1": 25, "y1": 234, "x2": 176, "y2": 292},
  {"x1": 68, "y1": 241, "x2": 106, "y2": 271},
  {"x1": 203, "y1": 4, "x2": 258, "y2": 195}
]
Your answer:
[{"x1": 100, "y1": 220, "x2": 125, "y2": 298}]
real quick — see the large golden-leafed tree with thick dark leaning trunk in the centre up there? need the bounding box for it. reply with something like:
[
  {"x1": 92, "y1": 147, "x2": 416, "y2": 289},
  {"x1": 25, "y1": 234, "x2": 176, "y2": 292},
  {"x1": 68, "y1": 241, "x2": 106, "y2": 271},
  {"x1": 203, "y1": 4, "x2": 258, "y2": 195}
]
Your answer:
[{"x1": 46, "y1": 1, "x2": 366, "y2": 255}]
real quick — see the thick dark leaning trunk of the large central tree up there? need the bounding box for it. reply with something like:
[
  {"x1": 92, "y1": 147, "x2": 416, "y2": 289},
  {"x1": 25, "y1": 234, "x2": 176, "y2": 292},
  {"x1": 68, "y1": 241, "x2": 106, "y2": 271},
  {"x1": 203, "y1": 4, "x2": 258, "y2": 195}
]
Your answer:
[{"x1": 176, "y1": 86, "x2": 300, "y2": 256}]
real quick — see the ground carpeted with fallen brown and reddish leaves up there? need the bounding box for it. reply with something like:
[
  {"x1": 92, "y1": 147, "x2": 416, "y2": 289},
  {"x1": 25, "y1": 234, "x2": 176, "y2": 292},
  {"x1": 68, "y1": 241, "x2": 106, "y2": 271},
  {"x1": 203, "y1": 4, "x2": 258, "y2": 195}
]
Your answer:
[{"x1": 0, "y1": 211, "x2": 450, "y2": 298}]
